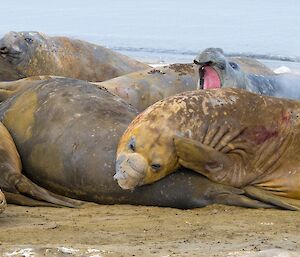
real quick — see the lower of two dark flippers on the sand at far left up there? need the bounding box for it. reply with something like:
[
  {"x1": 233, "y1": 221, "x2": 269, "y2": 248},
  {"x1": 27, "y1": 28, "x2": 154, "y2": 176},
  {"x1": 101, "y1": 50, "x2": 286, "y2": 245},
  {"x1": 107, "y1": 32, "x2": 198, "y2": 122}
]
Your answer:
[{"x1": 3, "y1": 192, "x2": 61, "y2": 207}]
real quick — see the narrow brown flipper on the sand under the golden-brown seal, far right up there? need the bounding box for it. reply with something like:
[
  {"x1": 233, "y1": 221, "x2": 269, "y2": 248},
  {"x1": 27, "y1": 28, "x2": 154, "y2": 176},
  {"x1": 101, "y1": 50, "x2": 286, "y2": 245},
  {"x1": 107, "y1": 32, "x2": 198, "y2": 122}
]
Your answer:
[{"x1": 243, "y1": 186, "x2": 300, "y2": 211}]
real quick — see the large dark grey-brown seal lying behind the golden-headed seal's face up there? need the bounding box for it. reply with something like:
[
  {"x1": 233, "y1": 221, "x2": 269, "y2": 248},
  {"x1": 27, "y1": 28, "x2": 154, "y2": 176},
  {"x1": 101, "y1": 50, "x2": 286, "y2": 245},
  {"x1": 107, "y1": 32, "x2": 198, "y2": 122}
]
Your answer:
[{"x1": 0, "y1": 78, "x2": 275, "y2": 208}]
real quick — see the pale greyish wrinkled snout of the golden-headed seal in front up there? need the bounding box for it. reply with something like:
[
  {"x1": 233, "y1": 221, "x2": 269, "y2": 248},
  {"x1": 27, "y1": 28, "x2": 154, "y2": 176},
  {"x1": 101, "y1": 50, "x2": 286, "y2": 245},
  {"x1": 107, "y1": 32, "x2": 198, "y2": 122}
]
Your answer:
[{"x1": 114, "y1": 153, "x2": 148, "y2": 189}]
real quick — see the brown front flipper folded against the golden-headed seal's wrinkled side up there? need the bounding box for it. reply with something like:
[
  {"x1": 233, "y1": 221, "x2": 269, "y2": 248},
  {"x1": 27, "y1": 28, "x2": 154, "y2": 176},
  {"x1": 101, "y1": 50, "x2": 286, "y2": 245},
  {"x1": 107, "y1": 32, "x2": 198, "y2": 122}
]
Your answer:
[{"x1": 174, "y1": 136, "x2": 233, "y2": 176}]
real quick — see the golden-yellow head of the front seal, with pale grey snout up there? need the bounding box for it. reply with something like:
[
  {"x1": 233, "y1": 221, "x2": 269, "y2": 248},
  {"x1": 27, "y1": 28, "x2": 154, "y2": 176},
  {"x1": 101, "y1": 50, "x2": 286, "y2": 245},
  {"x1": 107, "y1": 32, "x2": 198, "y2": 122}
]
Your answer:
[{"x1": 114, "y1": 109, "x2": 179, "y2": 189}]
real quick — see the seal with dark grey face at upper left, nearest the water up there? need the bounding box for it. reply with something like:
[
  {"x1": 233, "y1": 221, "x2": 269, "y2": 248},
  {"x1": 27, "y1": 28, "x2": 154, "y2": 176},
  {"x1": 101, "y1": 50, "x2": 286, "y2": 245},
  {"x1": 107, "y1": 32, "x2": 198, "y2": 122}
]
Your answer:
[{"x1": 0, "y1": 31, "x2": 149, "y2": 81}]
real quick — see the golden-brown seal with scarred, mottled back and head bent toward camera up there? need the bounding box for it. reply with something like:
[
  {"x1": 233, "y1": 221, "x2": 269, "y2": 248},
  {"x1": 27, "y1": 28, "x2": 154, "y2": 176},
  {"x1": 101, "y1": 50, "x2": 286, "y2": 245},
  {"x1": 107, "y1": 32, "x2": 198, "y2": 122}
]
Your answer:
[{"x1": 114, "y1": 88, "x2": 300, "y2": 209}]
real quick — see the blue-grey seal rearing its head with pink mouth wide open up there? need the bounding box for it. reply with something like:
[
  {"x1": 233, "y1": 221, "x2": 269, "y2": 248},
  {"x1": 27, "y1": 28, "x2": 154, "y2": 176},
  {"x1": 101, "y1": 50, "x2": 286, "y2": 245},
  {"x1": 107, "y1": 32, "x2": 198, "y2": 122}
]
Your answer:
[{"x1": 194, "y1": 48, "x2": 300, "y2": 99}]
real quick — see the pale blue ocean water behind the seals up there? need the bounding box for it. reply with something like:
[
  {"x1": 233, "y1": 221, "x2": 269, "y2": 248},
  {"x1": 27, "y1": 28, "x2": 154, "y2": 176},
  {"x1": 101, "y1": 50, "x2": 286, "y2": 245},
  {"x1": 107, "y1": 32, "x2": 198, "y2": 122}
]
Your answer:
[{"x1": 0, "y1": 0, "x2": 300, "y2": 71}]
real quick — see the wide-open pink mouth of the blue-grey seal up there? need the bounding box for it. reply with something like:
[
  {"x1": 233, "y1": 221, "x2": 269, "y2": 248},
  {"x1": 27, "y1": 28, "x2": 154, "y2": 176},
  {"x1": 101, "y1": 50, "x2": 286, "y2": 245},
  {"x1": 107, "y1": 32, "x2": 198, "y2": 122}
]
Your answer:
[{"x1": 198, "y1": 65, "x2": 221, "y2": 89}]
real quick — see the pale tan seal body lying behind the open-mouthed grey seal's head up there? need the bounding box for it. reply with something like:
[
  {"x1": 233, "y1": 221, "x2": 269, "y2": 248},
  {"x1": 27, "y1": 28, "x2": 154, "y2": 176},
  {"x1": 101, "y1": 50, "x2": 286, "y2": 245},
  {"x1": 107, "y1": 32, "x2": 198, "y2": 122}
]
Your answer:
[{"x1": 97, "y1": 57, "x2": 273, "y2": 111}]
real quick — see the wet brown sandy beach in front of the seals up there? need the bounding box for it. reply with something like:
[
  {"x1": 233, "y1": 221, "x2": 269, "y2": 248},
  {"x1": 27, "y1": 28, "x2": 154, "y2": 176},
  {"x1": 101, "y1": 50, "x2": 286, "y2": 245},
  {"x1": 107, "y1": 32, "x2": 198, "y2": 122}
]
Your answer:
[{"x1": 0, "y1": 204, "x2": 300, "y2": 257}]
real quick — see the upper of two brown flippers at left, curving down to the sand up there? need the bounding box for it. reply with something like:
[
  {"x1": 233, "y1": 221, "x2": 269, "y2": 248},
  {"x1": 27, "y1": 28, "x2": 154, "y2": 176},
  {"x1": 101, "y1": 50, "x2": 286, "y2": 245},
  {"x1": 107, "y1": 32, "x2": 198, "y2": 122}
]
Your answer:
[{"x1": 15, "y1": 174, "x2": 83, "y2": 208}]
